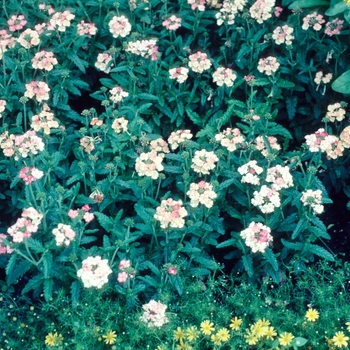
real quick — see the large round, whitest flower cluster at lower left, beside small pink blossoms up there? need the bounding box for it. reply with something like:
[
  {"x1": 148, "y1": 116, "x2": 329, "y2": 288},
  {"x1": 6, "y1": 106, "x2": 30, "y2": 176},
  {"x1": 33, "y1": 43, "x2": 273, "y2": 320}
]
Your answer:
[{"x1": 77, "y1": 256, "x2": 112, "y2": 289}]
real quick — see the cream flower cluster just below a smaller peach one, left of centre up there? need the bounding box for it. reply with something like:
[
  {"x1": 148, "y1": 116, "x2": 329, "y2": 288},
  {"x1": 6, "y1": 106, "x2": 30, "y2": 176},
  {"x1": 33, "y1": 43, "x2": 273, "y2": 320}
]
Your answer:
[{"x1": 135, "y1": 151, "x2": 164, "y2": 180}]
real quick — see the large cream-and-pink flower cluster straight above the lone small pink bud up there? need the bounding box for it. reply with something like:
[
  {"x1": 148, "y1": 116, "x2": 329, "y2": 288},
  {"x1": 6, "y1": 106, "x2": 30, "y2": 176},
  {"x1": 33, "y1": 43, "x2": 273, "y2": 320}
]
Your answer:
[{"x1": 154, "y1": 198, "x2": 187, "y2": 228}]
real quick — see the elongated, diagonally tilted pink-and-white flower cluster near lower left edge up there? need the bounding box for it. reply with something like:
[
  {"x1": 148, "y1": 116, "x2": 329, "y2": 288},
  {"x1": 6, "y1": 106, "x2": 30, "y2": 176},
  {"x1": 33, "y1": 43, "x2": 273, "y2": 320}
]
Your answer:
[{"x1": 7, "y1": 207, "x2": 43, "y2": 243}]
